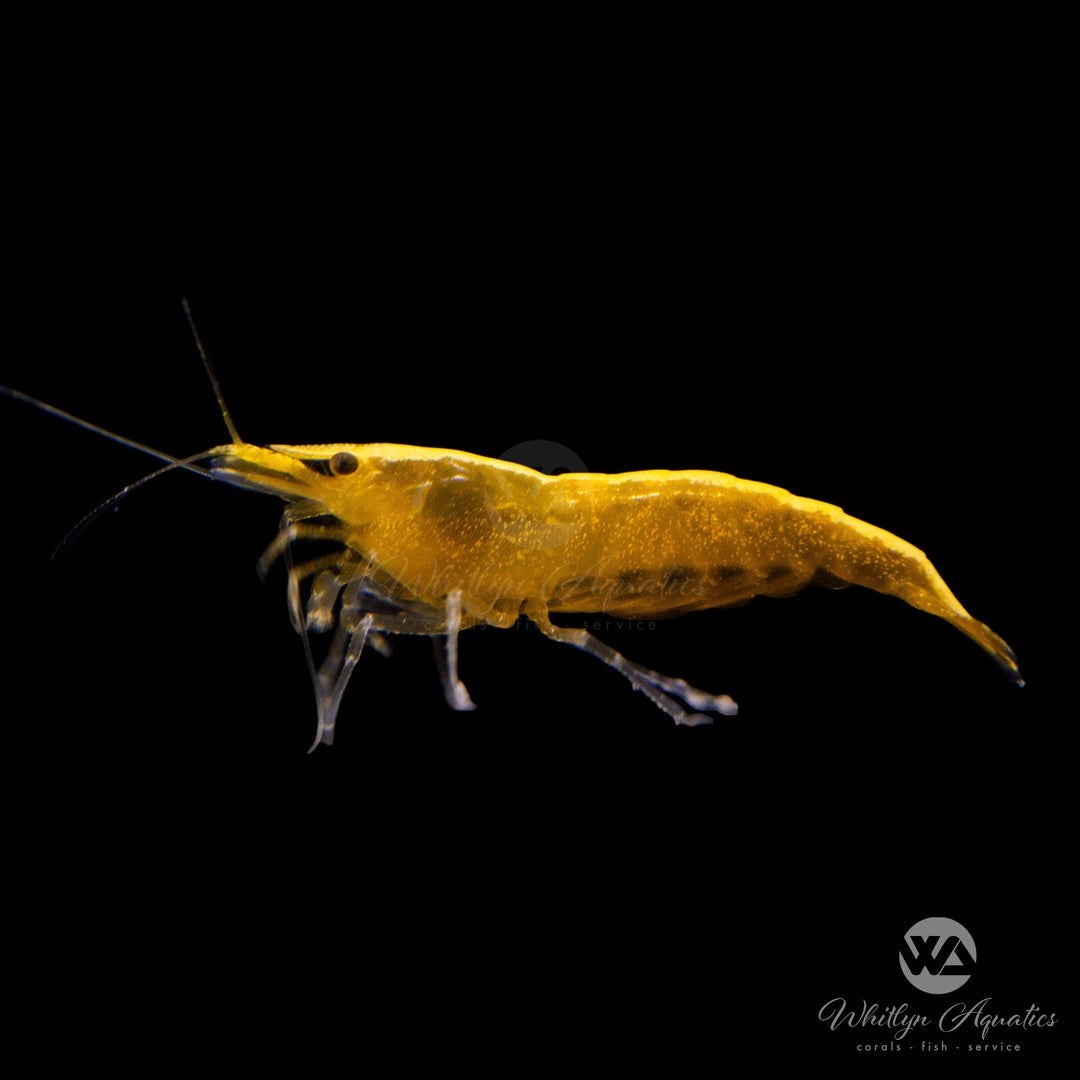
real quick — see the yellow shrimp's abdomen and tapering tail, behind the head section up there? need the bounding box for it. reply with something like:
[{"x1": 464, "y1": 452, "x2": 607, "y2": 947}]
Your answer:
[{"x1": 540, "y1": 472, "x2": 1023, "y2": 685}]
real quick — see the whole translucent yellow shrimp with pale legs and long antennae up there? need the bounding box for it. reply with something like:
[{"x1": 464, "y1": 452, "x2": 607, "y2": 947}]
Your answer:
[{"x1": 0, "y1": 306, "x2": 1023, "y2": 750}]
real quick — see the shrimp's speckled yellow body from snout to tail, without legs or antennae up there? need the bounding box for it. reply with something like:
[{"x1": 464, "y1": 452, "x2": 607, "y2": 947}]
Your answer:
[{"x1": 216, "y1": 444, "x2": 1018, "y2": 681}]
